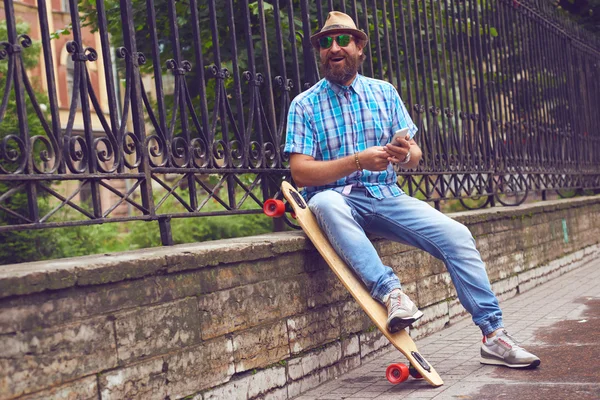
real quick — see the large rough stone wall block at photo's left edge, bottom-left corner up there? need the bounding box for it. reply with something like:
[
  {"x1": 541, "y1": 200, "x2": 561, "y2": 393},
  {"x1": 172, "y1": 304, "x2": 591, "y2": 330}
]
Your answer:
[{"x1": 0, "y1": 317, "x2": 117, "y2": 397}]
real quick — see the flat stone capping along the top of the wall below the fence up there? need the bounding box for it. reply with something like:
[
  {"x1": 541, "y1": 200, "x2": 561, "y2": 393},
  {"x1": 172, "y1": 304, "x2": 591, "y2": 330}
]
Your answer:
[{"x1": 0, "y1": 196, "x2": 600, "y2": 299}]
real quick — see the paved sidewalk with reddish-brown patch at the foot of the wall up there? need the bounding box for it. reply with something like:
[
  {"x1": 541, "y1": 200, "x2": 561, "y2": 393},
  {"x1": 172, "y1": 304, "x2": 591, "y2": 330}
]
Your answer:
[{"x1": 295, "y1": 259, "x2": 600, "y2": 400}]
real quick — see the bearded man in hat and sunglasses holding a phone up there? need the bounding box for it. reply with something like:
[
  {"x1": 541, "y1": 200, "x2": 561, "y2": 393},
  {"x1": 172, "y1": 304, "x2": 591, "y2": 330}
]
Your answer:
[{"x1": 285, "y1": 11, "x2": 540, "y2": 368}]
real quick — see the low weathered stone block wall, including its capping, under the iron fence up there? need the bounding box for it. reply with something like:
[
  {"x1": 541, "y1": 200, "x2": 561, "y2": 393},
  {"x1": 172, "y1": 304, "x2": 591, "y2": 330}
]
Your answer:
[{"x1": 0, "y1": 197, "x2": 600, "y2": 400}]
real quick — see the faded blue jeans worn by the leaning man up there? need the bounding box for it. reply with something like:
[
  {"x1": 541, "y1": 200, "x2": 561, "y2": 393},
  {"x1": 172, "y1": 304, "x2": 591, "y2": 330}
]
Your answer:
[{"x1": 308, "y1": 188, "x2": 503, "y2": 335}]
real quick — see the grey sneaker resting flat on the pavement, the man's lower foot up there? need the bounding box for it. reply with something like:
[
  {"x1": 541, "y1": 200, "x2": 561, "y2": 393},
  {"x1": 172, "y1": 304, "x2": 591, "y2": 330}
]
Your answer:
[{"x1": 479, "y1": 329, "x2": 541, "y2": 368}]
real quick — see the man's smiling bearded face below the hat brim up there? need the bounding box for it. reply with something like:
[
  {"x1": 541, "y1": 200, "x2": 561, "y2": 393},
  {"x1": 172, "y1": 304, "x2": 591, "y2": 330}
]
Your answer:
[{"x1": 319, "y1": 35, "x2": 363, "y2": 86}]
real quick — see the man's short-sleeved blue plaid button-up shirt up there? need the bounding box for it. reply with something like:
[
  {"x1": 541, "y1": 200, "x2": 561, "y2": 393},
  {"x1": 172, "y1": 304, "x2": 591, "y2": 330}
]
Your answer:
[{"x1": 284, "y1": 75, "x2": 417, "y2": 199}]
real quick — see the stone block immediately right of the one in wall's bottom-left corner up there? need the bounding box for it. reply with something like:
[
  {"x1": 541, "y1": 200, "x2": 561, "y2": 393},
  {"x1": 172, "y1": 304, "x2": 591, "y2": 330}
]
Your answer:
[{"x1": 115, "y1": 298, "x2": 201, "y2": 363}]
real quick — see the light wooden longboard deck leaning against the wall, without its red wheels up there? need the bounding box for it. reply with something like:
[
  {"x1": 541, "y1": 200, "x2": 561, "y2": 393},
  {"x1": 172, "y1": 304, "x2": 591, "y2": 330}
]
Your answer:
[{"x1": 281, "y1": 182, "x2": 444, "y2": 387}]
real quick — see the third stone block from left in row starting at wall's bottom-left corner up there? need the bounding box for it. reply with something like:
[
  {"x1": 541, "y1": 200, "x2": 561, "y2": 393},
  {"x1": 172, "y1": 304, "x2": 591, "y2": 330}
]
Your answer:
[{"x1": 198, "y1": 277, "x2": 306, "y2": 340}]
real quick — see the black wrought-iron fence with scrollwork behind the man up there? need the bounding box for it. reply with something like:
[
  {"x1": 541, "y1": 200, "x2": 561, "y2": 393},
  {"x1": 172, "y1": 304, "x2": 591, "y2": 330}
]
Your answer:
[{"x1": 0, "y1": 0, "x2": 600, "y2": 244}]
